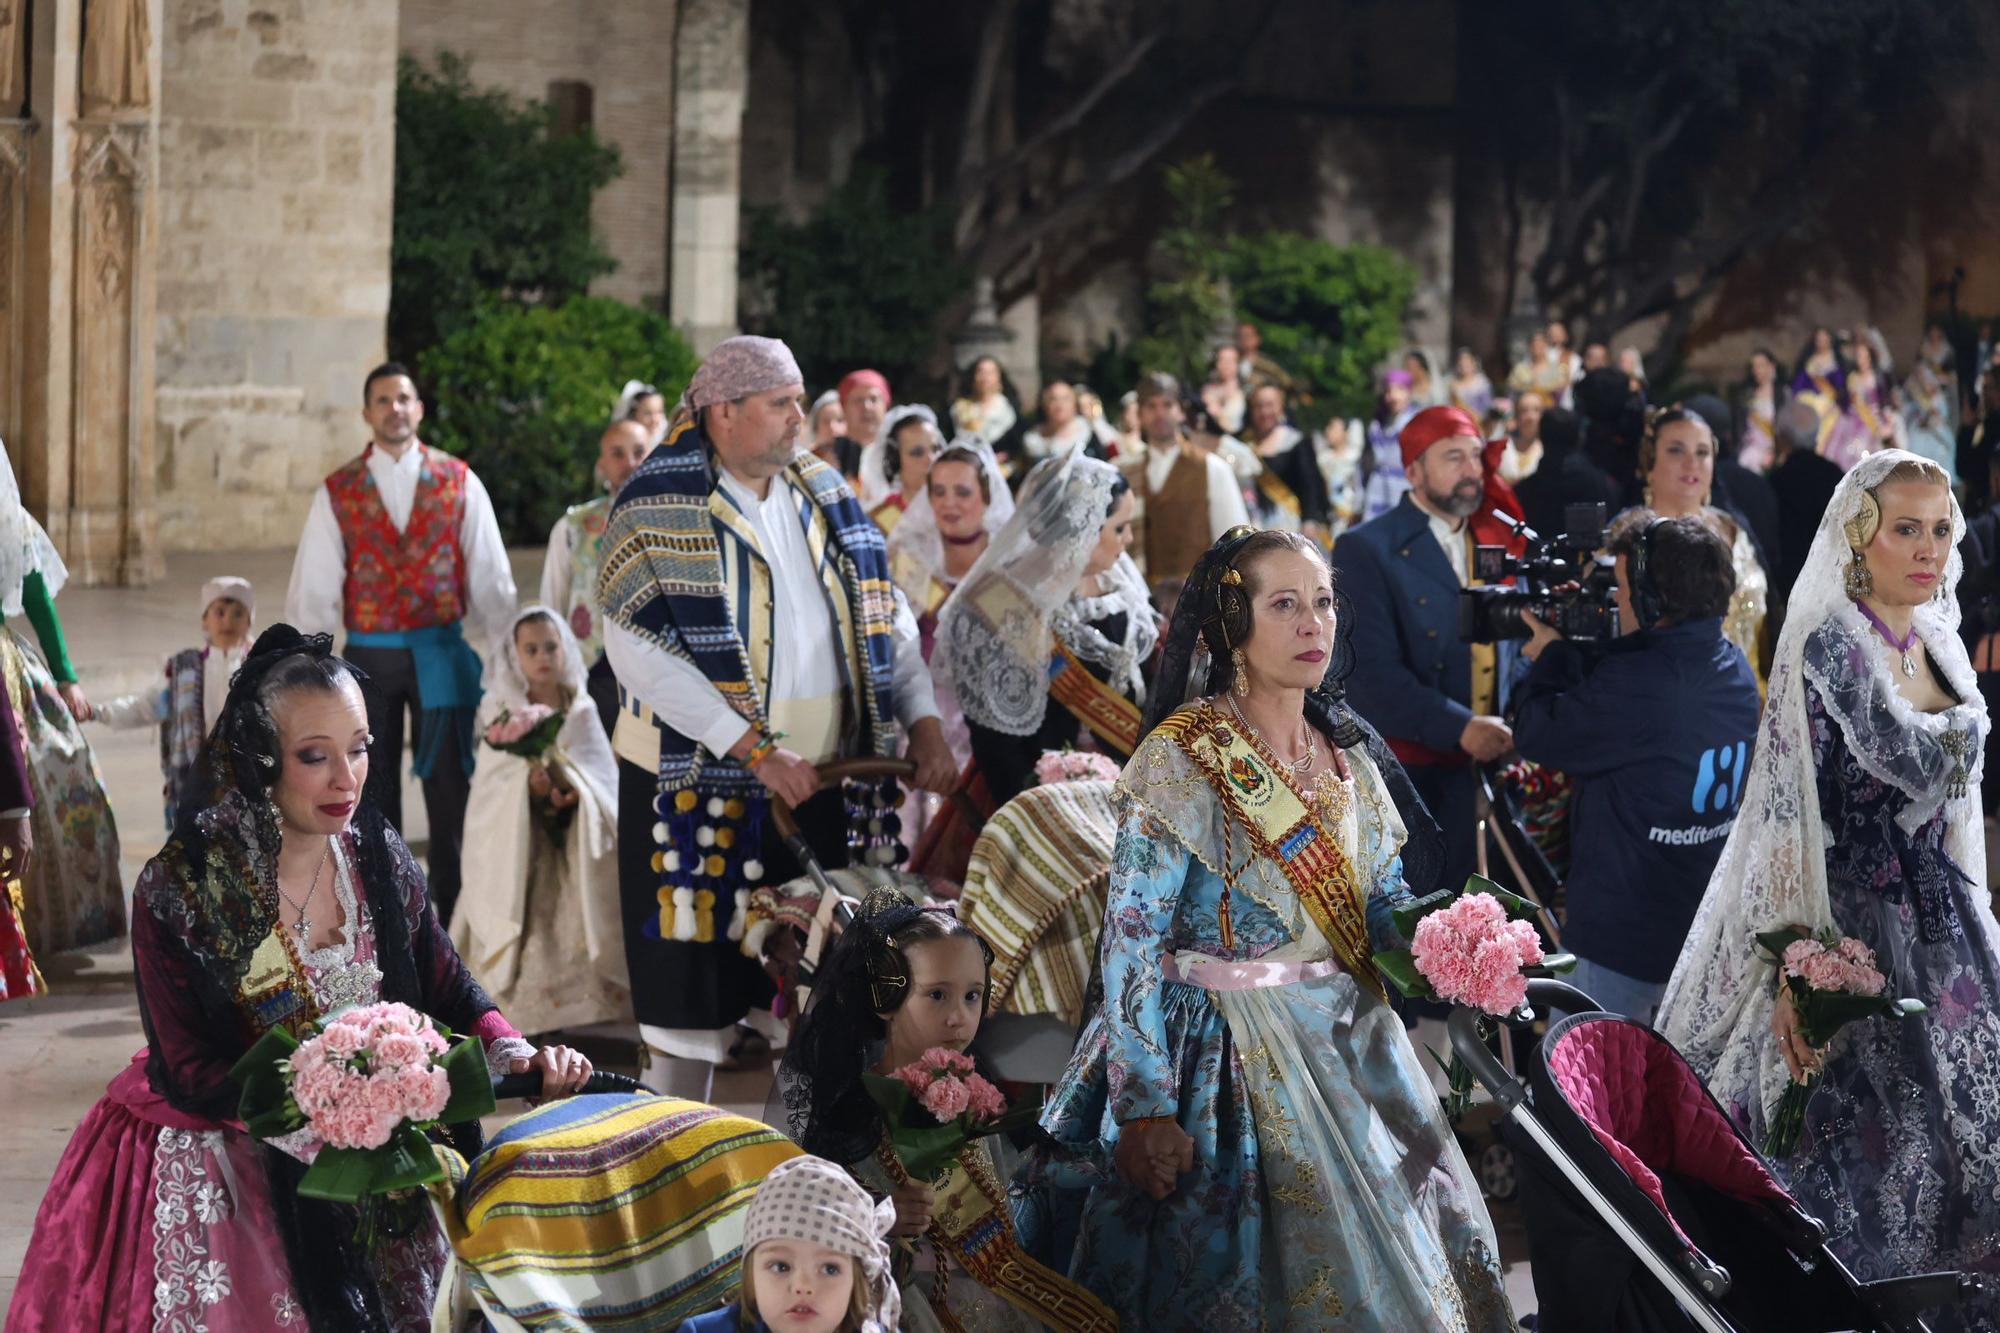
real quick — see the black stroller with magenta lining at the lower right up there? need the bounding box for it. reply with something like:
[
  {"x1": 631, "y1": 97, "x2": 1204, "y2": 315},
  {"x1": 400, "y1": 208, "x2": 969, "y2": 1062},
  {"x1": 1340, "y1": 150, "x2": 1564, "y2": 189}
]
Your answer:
[{"x1": 1450, "y1": 981, "x2": 1980, "y2": 1333}]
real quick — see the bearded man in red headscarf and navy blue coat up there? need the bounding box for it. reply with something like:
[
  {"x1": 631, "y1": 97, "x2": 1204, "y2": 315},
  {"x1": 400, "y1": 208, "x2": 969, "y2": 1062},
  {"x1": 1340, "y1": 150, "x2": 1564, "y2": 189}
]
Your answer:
[{"x1": 1334, "y1": 406, "x2": 1514, "y2": 889}]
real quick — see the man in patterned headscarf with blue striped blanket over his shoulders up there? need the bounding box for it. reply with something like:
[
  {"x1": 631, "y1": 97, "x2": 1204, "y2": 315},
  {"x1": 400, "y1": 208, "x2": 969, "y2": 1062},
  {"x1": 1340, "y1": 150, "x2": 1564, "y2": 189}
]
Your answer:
[{"x1": 598, "y1": 336, "x2": 956, "y2": 1101}]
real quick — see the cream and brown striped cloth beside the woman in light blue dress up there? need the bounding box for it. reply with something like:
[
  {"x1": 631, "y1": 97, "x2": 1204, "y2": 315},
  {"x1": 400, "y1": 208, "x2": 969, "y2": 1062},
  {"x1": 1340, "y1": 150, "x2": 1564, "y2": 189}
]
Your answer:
[{"x1": 958, "y1": 783, "x2": 1118, "y2": 1023}]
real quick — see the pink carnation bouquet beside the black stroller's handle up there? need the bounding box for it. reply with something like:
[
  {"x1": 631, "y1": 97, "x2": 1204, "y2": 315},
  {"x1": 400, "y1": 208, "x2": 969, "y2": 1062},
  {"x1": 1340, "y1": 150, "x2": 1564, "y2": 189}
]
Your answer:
[{"x1": 1374, "y1": 875, "x2": 1576, "y2": 1121}]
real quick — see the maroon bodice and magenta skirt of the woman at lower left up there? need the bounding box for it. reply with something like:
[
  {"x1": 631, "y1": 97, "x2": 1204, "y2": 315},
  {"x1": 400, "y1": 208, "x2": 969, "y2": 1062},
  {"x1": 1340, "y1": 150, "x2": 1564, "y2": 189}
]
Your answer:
[{"x1": 8, "y1": 793, "x2": 532, "y2": 1333}]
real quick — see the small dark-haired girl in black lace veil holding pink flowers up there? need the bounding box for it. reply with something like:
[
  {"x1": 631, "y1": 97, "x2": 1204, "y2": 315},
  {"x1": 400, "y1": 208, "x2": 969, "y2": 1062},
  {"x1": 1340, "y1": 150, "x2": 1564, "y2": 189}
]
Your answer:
[{"x1": 774, "y1": 891, "x2": 1118, "y2": 1333}]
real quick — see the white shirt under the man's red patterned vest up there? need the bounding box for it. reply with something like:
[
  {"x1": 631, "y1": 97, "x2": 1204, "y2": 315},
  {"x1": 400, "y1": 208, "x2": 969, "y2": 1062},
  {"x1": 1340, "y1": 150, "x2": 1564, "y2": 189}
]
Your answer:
[{"x1": 284, "y1": 442, "x2": 516, "y2": 656}]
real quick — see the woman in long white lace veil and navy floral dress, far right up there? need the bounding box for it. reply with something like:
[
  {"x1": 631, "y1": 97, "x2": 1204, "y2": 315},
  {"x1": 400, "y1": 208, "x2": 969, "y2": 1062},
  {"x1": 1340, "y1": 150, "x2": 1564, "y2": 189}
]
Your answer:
[{"x1": 1660, "y1": 450, "x2": 2000, "y2": 1304}]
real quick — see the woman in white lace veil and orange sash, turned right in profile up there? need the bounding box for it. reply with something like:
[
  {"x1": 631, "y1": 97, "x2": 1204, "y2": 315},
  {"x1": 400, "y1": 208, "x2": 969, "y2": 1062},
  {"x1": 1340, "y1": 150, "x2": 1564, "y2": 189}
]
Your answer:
[{"x1": 934, "y1": 450, "x2": 1160, "y2": 807}]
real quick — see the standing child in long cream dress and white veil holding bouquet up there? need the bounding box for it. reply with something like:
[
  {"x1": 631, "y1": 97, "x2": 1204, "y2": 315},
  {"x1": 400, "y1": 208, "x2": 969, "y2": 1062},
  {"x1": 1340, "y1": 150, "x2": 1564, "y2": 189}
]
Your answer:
[{"x1": 452, "y1": 604, "x2": 632, "y2": 1033}]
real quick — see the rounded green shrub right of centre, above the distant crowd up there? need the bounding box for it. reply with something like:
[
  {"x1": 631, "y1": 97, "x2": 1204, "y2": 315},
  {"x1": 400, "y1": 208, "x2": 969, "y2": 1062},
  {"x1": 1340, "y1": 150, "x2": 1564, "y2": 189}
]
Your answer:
[{"x1": 1224, "y1": 232, "x2": 1416, "y2": 426}]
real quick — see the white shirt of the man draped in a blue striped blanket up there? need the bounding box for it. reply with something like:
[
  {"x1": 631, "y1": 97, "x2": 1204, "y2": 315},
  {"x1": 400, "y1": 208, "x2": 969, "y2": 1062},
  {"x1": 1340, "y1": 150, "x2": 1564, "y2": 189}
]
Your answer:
[{"x1": 604, "y1": 470, "x2": 938, "y2": 755}]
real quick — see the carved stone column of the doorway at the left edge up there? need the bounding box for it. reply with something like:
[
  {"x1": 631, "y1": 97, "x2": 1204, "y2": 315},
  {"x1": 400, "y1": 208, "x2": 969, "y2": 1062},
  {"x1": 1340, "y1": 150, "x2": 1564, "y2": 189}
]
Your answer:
[{"x1": 0, "y1": 0, "x2": 162, "y2": 584}]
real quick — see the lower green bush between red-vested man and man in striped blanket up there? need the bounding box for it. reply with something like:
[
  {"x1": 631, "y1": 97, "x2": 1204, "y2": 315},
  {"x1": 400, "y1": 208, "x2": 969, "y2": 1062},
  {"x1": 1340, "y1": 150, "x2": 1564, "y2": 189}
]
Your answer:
[{"x1": 418, "y1": 296, "x2": 698, "y2": 546}]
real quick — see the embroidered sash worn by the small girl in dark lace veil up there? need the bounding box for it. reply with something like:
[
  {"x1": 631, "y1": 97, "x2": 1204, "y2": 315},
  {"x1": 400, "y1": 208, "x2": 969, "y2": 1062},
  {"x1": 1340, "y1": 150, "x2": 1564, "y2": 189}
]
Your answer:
[{"x1": 878, "y1": 1143, "x2": 1118, "y2": 1333}]
